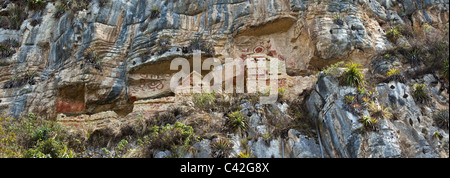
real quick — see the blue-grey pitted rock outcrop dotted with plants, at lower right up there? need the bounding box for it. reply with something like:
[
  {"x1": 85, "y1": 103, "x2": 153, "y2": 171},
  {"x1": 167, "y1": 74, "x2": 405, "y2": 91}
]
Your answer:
[{"x1": 307, "y1": 75, "x2": 447, "y2": 158}]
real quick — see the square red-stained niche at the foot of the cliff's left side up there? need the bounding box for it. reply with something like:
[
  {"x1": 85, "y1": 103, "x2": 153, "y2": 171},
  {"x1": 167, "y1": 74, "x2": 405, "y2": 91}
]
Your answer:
[{"x1": 56, "y1": 83, "x2": 86, "y2": 115}]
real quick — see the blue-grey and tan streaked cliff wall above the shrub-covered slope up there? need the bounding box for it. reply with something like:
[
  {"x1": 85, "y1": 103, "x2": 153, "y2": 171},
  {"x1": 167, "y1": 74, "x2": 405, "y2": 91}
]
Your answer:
[{"x1": 0, "y1": 0, "x2": 449, "y2": 158}]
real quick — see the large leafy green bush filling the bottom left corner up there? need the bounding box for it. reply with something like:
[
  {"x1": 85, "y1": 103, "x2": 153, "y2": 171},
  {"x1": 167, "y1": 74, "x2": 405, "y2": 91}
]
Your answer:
[{"x1": 0, "y1": 113, "x2": 75, "y2": 158}]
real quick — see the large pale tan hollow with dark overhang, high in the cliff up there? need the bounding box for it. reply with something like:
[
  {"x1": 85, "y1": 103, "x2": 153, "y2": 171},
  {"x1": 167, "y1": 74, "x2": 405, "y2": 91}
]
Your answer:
[{"x1": 232, "y1": 19, "x2": 314, "y2": 76}]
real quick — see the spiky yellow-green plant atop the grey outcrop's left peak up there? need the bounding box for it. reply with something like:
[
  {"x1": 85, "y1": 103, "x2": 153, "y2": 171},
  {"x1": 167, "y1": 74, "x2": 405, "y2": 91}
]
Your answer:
[{"x1": 342, "y1": 62, "x2": 365, "y2": 87}]
